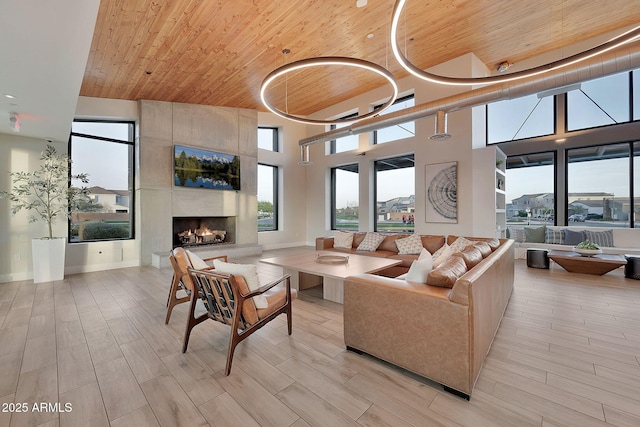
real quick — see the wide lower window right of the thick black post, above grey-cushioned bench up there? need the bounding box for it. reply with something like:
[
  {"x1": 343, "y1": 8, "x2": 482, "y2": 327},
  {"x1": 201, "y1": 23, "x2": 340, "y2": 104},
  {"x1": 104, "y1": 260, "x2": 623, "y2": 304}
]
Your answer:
[{"x1": 567, "y1": 143, "x2": 632, "y2": 227}]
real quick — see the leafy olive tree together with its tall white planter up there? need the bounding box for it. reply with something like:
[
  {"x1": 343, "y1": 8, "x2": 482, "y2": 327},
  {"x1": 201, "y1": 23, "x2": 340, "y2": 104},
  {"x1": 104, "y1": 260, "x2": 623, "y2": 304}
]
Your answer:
[{"x1": 0, "y1": 145, "x2": 89, "y2": 283}]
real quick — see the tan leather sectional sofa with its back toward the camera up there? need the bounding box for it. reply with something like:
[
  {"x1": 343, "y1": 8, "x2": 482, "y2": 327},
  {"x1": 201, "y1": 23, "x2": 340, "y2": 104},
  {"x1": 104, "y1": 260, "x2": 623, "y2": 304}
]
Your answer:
[{"x1": 316, "y1": 232, "x2": 514, "y2": 399}]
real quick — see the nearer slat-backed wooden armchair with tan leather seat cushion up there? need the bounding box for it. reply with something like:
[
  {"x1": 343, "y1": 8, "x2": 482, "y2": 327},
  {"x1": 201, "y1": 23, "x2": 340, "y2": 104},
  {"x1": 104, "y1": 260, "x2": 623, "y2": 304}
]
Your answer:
[{"x1": 182, "y1": 268, "x2": 297, "y2": 375}]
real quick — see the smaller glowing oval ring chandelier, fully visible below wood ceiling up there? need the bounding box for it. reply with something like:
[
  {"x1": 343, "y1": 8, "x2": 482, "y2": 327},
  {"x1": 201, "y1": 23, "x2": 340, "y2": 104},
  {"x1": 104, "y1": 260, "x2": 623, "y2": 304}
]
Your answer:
[{"x1": 260, "y1": 56, "x2": 398, "y2": 125}]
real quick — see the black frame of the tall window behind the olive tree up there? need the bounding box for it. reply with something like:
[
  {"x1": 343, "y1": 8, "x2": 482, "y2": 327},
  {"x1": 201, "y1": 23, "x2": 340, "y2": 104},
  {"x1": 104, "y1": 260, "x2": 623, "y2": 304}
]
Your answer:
[{"x1": 67, "y1": 119, "x2": 136, "y2": 244}]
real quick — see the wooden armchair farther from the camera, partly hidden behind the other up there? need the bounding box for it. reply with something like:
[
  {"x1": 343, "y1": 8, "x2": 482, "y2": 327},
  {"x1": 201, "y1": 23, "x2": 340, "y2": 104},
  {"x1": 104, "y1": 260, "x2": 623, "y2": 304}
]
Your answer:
[{"x1": 164, "y1": 248, "x2": 227, "y2": 353}]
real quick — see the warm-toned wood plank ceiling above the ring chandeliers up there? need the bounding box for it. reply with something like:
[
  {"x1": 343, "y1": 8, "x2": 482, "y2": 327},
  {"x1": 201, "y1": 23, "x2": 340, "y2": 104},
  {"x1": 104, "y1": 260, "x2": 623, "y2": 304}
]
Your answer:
[{"x1": 80, "y1": 0, "x2": 640, "y2": 115}]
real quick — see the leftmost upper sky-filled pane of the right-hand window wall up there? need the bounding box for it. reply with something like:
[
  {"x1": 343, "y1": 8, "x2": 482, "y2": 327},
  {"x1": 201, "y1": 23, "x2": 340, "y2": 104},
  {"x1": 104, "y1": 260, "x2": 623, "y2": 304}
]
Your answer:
[{"x1": 487, "y1": 95, "x2": 555, "y2": 144}]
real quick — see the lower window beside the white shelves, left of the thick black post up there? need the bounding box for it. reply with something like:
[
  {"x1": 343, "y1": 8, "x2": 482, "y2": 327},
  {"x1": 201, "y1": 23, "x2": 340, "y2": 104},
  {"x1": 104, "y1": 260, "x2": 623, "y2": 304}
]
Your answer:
[{"x1": 506, "y1": 152, "x2": 556, "y2": 226}]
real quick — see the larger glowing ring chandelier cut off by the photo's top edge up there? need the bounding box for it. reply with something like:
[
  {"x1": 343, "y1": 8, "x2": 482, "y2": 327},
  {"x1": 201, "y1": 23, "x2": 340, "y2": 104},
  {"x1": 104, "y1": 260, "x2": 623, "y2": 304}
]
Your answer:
[{"x1": 391, "y1": 0, "x2": 640, "y2": 86}]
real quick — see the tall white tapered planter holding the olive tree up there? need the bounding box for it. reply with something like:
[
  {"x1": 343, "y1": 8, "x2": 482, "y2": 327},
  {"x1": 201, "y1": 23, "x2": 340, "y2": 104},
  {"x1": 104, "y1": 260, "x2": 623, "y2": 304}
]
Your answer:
[{"x1": 31, "y1": 237, "x2": 67, "y2": 283}]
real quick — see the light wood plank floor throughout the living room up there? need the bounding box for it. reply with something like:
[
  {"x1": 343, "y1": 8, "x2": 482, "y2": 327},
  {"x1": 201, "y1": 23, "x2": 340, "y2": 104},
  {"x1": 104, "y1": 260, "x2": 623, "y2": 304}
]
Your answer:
[{"x1": 0, "y1": 249, "x2": 640, "y2": 427}]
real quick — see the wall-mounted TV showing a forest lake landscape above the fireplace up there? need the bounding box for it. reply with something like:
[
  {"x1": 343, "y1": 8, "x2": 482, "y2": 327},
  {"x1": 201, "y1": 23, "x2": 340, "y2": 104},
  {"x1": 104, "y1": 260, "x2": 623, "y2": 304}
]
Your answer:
[{"x1": 174, "y1": 145, "x2": 240, "y2": 190}]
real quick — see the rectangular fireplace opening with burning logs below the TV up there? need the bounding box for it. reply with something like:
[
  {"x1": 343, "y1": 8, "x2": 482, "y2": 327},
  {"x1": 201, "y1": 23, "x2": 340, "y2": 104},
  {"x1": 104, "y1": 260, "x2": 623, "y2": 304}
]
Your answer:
[{"x1": 173, "y1": 217, "x2": 236, "y2": 248}]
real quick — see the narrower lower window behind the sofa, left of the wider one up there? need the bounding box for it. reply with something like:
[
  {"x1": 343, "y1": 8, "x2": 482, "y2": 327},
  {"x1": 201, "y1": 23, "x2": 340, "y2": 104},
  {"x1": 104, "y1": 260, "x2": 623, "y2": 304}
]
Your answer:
[{"x1": 331, "y1": 163, "x2": 360, "y2": 231}]
